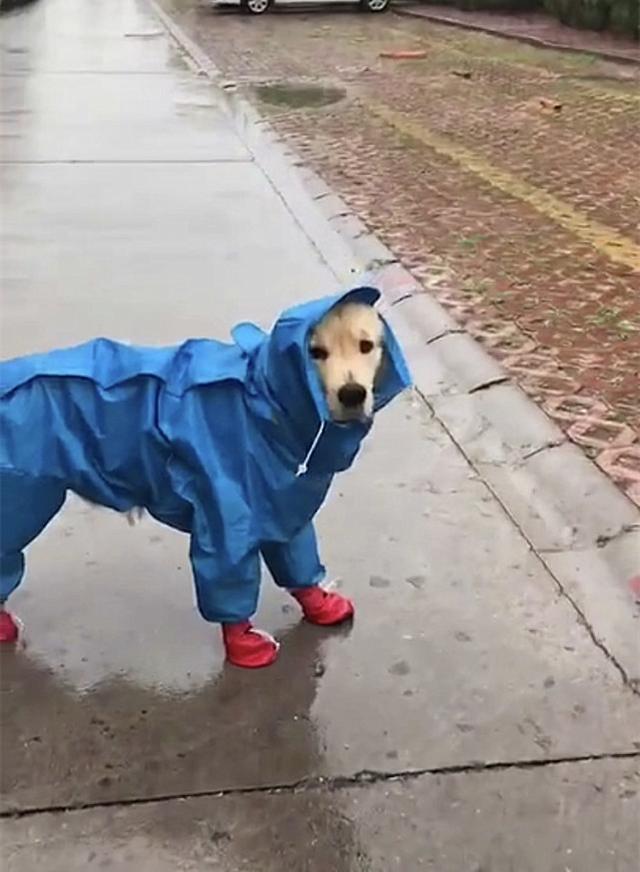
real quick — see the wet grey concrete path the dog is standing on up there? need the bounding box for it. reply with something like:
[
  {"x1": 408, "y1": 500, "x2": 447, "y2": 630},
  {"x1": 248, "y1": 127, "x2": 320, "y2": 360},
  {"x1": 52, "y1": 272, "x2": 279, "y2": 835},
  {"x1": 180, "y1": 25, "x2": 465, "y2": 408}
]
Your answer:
[{"x1": 1, "y1": 0, "x2": 640, "y2": 872}]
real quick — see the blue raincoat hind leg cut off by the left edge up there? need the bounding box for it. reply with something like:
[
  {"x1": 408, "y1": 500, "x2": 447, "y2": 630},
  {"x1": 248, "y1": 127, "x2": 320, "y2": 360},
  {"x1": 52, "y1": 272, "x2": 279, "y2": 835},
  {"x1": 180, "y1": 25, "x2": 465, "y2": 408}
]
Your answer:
[{"x1": 0, "y1": 467, "x2": 66, "y2": 604}]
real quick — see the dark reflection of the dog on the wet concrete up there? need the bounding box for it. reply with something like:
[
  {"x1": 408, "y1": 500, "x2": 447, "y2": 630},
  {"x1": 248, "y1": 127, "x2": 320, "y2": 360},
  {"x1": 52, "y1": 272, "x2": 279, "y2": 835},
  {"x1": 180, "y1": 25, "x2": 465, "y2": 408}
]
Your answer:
[{"x1": 0, "y1": 624, "x2": 366, "y2": 872}]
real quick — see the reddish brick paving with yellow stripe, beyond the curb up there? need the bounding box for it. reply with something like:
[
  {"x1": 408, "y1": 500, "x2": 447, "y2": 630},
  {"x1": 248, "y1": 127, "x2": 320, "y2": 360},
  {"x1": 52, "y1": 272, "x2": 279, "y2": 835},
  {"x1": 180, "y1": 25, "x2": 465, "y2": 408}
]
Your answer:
[{"x1": 160, "y1": 0, "x2": 640, "y2": 504}]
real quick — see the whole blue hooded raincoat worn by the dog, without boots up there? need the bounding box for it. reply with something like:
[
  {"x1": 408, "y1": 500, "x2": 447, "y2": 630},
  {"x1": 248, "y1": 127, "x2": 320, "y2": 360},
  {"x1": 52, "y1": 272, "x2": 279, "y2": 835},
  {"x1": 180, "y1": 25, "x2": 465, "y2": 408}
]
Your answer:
[{"x1": 0, "y1": 287, "x2": 410, "y2": 622}]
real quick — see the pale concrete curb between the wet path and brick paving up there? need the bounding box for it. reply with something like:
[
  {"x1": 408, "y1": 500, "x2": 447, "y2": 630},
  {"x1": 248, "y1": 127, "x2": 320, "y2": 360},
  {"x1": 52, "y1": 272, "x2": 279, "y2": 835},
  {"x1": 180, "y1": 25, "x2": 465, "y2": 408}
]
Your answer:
[{"x1": 147, "y1": 0, "x2": 640, "y2": 695}]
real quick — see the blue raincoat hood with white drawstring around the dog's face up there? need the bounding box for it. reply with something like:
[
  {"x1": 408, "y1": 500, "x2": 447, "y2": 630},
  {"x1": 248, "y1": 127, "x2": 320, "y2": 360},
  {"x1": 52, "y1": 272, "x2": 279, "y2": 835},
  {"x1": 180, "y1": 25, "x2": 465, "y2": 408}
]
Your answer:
[{"x1": 232, "y1": 286, "x2": 411, "y2": 475}]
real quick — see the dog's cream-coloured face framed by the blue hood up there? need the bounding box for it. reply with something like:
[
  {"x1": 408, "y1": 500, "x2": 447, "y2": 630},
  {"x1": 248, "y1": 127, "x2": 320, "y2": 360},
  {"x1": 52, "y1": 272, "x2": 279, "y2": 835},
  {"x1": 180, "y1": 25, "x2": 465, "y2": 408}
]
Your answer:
[{"x1": 309, "y1": 303, "x2": 384, "y2": 422}]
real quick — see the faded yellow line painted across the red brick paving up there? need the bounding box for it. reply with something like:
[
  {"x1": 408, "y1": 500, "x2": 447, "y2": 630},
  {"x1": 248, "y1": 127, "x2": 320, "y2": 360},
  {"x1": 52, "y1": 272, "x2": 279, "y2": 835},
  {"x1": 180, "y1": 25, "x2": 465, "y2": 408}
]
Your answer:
[{"x1": 361, "y1": 98, "x2": 640, "y2": 271}]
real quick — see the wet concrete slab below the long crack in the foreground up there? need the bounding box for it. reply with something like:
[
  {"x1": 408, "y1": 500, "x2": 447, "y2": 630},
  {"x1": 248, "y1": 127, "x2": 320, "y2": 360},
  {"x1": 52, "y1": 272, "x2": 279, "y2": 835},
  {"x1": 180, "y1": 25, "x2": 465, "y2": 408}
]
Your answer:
[{"x1": 8, "y1": 761, "x2": 640, "y2": 872}]
